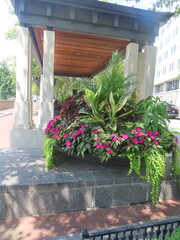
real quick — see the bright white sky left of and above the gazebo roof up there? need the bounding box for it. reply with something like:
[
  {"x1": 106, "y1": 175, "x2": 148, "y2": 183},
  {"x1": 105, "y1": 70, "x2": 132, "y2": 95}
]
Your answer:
[{"x1": 0, "y1": 0, "x2": 157, "y2": 61}]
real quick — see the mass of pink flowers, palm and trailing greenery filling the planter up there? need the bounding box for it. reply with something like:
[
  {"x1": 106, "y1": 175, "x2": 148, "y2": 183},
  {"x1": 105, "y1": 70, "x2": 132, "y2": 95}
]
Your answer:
[{"x1": 44, "y1": 54, "x2": 180, "y2": 204}]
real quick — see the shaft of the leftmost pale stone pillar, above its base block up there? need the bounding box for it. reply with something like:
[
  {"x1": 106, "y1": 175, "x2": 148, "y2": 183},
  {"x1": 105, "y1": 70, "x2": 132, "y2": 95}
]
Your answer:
[{"x1": 13, "y1": 26, "x2": 32, "y2": 129}]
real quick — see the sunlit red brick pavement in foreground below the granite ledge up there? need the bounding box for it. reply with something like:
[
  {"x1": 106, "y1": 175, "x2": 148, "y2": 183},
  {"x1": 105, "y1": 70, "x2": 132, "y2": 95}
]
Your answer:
[{"x1": 0, "y1": 200, "x2": 180, "y2": 240}]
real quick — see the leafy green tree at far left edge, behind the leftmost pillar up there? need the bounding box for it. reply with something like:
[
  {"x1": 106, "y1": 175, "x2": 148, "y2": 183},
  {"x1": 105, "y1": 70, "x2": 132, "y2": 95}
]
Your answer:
[{"x1": 0, "y1": 60, "x2": 16, "y2": 100}]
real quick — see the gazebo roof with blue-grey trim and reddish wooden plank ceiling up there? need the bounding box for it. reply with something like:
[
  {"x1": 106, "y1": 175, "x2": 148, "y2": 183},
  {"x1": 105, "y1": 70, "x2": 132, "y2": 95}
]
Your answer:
[{"x1": 12, "y1": 0, "x2": 172, "y2": 76}]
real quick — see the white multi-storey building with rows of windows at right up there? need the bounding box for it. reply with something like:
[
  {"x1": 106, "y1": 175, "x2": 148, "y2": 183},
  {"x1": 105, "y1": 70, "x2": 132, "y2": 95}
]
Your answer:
[{"x1": 153, "y1": 16, "x2": 180, "y2": 108}]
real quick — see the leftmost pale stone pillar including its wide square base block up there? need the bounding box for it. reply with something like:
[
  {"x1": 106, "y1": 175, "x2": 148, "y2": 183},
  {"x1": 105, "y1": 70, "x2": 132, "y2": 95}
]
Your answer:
[{"x1": 10, "y1": 26, "x2": 43, "y2": 148}]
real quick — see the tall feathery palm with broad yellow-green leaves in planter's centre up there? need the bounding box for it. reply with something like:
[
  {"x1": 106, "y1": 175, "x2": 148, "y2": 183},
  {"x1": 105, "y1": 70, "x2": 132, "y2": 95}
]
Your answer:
[{"x1": 76, "y1": 52, "x2": 135, "y2": 132}]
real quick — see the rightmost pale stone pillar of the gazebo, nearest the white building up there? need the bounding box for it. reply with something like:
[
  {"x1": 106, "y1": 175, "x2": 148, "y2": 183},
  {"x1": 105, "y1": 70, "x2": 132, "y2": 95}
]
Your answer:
[{"x1": 137, "y1": 45, "x2": 157, "y2": 100}]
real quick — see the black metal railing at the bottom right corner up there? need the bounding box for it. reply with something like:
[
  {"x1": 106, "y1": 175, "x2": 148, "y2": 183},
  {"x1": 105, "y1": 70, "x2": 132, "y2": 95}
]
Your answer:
[{"x1": 82, "y1": 217, "x2": 180, "y2": 240}]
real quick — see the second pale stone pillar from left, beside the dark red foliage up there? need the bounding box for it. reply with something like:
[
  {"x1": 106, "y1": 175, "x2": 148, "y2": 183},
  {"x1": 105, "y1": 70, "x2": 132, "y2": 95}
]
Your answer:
[{"x1": 38, "y1": 30, "x2": 55, "y2": 129}]
